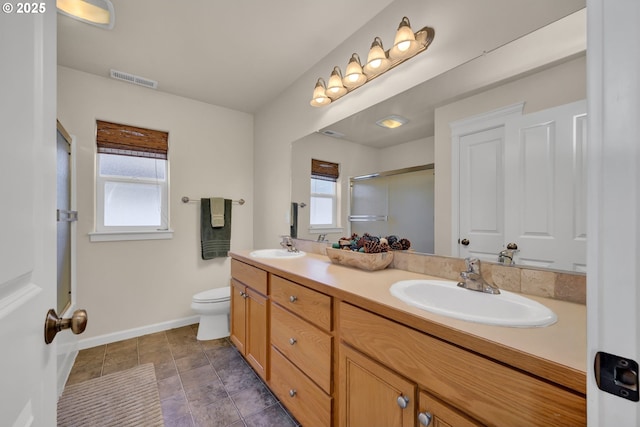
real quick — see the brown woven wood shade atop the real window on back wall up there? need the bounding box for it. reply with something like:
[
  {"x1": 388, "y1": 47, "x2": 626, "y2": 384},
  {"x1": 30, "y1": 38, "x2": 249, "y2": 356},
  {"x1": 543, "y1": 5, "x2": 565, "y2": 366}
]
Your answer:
[{"x1": 96, "y1": 120, "x2": 169, "y2": 159}]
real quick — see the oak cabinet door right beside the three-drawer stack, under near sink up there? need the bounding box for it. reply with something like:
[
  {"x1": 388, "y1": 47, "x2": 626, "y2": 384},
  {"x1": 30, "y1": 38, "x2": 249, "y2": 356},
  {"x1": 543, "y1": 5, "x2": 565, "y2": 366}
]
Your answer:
[{"x1": 339, "y1": 344, "x2": 416, "y2": 427}]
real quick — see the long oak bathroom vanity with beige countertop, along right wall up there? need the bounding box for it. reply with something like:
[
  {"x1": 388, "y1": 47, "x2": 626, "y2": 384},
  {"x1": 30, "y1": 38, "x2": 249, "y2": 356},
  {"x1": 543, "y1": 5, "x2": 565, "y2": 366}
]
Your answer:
[{"x1": 230, "y1": 251, "x2": 586, "y2": 427}]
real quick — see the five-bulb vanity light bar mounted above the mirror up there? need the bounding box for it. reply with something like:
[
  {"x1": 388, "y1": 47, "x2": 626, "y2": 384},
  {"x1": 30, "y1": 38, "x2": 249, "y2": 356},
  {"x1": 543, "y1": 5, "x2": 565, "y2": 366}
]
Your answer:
[{"x1": 311, "y1": 16, "x2": 435, "y2": 107}]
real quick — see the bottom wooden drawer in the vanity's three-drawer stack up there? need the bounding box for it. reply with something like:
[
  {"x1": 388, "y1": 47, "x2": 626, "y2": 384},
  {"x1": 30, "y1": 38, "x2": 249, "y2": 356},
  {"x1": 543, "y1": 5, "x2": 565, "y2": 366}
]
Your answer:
[{"x1": 269, "y1": 346, "x2": 332, "y2": 426}]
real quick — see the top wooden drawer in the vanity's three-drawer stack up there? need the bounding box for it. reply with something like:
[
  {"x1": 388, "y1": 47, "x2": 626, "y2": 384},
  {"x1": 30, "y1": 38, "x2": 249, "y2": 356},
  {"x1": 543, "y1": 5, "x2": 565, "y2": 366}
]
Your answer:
[{"x1": 271, "y1": 276, "x2": 331, "y2": 331}]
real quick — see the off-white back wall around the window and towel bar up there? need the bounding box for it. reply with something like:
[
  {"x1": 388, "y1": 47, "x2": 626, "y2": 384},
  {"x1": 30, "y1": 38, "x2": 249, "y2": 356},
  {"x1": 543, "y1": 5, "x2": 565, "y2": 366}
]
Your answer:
[{"x1": 58, "y1": 67, "x2": 253, "y2": 347}]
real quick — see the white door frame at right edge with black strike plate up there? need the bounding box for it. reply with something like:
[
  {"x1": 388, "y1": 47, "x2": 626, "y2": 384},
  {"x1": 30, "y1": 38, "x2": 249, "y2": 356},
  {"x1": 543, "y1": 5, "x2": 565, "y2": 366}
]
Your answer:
[{"x1": 586, "y1": 0, "x2": 640, "y2": 427}]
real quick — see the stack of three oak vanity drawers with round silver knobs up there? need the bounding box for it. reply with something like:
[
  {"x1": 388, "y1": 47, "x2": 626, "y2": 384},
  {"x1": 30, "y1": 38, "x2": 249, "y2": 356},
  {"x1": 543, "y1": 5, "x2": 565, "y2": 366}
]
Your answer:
[{"x1": 268, "y1": 275, "x2": 333, "y2": 426}]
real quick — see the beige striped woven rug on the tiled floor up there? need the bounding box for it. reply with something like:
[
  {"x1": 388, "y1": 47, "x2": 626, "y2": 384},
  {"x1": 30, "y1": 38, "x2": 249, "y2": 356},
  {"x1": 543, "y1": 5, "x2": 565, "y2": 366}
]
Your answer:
[{"x1": 58, "y1": 363, "x2": 164, "y2": 427}]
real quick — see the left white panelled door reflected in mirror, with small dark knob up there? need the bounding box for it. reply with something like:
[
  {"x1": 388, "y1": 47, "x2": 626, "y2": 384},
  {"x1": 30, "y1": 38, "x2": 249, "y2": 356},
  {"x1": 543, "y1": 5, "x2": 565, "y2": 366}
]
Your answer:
[{"x1": 458, "y1": 126, "x2": 505, "y2": 261}]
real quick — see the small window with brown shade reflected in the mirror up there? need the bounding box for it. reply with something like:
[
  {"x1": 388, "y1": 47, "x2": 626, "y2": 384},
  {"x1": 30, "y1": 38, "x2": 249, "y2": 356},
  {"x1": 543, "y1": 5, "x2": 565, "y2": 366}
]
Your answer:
[{"x1": 309, "y1": 159, "x2": 339, "y2": 229}]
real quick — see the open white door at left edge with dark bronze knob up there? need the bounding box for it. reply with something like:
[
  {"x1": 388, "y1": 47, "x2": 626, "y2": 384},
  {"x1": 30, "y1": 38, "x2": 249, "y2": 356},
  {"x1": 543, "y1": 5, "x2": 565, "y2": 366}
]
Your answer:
[{"x1": 0, "y1": 1, "x2": 57, "y2": 426}]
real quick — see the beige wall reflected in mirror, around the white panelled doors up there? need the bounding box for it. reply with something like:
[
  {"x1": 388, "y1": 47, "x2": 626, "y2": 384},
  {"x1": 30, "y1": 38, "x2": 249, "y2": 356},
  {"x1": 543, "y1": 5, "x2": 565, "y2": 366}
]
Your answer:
[{"x1": 434, "y1": 56, "x2": 587, "y2": 255}]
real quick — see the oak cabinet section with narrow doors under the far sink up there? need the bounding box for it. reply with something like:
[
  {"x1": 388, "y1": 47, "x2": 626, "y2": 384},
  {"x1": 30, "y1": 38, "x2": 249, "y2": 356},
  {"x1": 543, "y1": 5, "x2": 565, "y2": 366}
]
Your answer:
[{"x1": 230, "y1": 259, "x2": 269, "y2": 381}]
